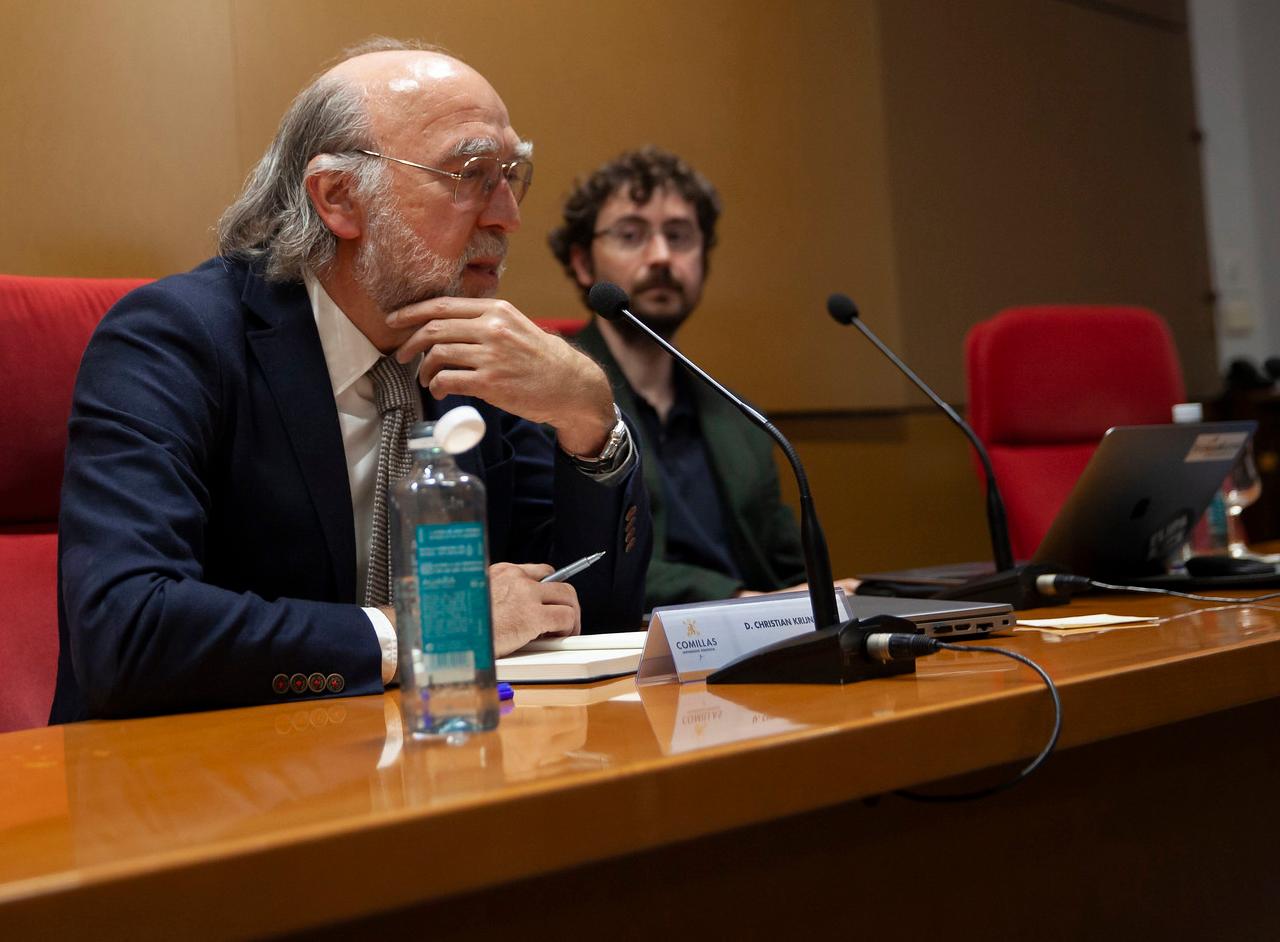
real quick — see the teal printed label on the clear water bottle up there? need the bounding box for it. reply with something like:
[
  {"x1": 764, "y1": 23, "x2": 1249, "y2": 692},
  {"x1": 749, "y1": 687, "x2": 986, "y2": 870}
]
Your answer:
[{"x1": 413, "y1": 522, "x2": 493, "y2": 683}]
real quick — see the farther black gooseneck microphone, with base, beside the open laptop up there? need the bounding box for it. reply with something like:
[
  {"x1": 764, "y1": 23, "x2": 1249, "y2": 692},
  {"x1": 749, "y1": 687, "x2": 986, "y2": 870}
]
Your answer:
[{"x1": 827, "y1": 293, "x2": 1066, "y2": 608}]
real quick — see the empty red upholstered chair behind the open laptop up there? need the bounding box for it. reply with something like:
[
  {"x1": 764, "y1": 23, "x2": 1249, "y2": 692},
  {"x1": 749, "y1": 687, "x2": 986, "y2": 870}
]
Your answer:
[{"x1": 965, "y1": 305, "x2": 1185, "y2": 559}]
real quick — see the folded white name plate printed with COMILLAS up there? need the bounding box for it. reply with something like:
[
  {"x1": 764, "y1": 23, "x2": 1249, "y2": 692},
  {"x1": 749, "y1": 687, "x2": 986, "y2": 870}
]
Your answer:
[{"x1": 636, "y1": 590, "x2": 849, "y2": 685}]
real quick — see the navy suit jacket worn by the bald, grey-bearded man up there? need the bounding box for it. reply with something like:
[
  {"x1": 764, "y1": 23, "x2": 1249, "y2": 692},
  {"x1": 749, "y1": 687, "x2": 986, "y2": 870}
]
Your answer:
[{"x1": 50, "y1": 259, "x2": 652, "y2": 723}]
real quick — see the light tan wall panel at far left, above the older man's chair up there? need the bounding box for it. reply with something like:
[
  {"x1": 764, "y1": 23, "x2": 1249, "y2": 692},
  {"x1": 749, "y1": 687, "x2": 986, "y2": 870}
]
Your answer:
[{"x1": 0, "y1": 0, "x2": 241, "y2": 276}]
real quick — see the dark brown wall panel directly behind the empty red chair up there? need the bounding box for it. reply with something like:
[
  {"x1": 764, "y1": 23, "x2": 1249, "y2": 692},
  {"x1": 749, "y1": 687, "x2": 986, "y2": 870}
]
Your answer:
[{"x1": 879, "y1": 0, "x2": 1216, "y2": 401}]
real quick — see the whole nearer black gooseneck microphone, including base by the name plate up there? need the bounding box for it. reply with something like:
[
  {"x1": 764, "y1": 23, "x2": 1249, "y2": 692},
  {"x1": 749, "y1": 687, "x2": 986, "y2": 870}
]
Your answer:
[{"x1": 586, "y1": 282, "x2": 915, "y2": 683}]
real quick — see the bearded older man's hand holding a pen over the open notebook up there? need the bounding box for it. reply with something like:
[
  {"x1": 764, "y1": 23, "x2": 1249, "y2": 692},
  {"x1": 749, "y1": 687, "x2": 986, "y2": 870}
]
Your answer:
[{"x1": 489, "y1": 563, "x2": 582, "y2": 658}]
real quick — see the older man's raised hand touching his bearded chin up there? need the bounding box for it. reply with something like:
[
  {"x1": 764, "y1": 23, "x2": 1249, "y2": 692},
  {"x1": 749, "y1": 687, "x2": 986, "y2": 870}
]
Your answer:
[{"x1": 387, "y1": 298, "x2": 616, "y2": 456}]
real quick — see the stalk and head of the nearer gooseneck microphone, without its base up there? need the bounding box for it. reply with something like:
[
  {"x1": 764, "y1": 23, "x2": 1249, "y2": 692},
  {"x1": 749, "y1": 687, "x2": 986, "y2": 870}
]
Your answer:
[{"x1": 586, "y1": 282, "x2": 838, "y2": 630}]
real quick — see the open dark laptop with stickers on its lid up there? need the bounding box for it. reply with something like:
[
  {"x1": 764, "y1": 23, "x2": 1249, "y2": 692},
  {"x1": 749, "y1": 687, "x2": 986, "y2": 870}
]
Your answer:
[{"x1": 860, "y1": 421, "x2": 1259, "y2": 594}]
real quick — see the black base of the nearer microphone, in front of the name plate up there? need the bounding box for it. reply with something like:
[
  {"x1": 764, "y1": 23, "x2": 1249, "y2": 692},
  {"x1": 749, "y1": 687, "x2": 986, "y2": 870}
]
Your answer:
[{"x1": 707, "y1": 614, "x2": 916, "y2": 683}]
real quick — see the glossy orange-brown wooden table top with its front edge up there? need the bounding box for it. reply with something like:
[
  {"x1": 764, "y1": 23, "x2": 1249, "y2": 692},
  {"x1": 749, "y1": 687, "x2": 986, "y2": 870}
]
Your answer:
[{"x1": 0, "y1": 596, "x2": 1280, "y2": 938}]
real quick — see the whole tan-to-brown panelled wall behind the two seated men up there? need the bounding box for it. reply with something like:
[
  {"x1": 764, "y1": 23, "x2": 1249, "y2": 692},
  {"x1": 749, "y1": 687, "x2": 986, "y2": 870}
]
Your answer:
[{"x1": 0, "y1": 0, "x2": 1213, "y2": 571}]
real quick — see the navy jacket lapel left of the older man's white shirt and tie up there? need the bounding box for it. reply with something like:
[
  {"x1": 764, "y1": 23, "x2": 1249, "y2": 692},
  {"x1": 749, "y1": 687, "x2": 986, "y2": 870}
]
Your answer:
[{"x1": 242, "y1": 271, "x2": 356, "y2": 602}]
